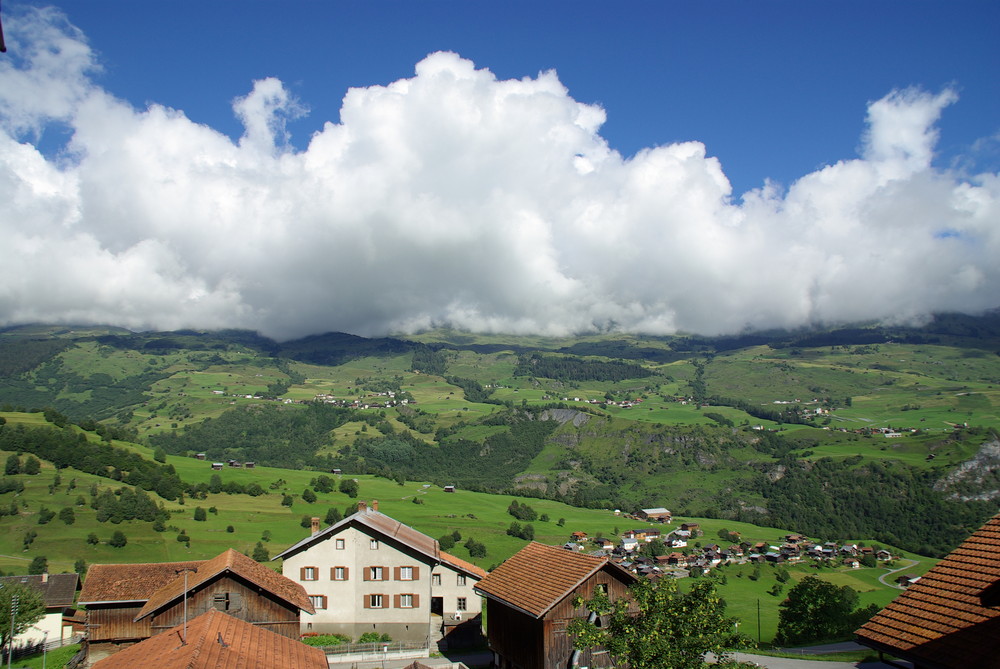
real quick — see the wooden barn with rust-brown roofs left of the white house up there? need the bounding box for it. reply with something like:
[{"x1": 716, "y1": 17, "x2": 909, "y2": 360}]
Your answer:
[{"x1": 79, "y1": 549, "x2": 314, "y2": 662}]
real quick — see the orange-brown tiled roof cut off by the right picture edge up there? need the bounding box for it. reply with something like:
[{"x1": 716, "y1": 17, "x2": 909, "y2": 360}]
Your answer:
[{"x1": 855, "y1": 514, "x2": 1000, "y2": 667}]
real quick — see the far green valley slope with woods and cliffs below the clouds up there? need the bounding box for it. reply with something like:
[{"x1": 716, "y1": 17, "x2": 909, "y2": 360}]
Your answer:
[{"x1": 0, "y1": 315, "x2": 1000, "y2": 555}]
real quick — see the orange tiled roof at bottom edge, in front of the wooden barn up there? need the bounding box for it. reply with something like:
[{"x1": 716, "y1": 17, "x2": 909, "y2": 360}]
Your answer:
[{"x1": 92, "y1": 609, "x2": 328, "y2": 669}]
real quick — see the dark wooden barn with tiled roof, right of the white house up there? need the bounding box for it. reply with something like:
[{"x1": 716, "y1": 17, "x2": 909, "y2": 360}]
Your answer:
[{"x1": 476, "y1": 542, "x2": 636, "y2": 669}]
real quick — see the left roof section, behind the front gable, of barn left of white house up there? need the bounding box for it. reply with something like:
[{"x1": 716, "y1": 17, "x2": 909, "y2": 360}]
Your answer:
[{"x1": 79, "y1": 560, "x2": 204, "y2": 606}]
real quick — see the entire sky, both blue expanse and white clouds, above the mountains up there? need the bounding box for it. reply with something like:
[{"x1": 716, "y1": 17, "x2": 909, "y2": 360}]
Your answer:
[{"x1": 0, "y1": 0, "x2": 1000, "y2": 340}]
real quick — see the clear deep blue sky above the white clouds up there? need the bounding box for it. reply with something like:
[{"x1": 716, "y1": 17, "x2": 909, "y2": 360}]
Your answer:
[{"x1": 31, "y1": 0, "x2": 1000, "y2": 195}]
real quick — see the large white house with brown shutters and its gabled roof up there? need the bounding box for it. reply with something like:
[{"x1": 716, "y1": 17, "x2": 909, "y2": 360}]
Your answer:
[{"x1": 274, "y1": 501, "x2": 486, "y2": 645}]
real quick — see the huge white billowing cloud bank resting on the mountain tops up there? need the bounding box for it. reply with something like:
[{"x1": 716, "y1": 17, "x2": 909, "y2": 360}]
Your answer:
[{"x1": 0, "y1": 10, "x2": 1000, "y2": 339}]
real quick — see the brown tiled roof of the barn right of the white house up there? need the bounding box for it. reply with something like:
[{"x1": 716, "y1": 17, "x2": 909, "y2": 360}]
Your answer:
[{"x1": 475, "y1": 541, "x2": 636, "y2": 618}]
